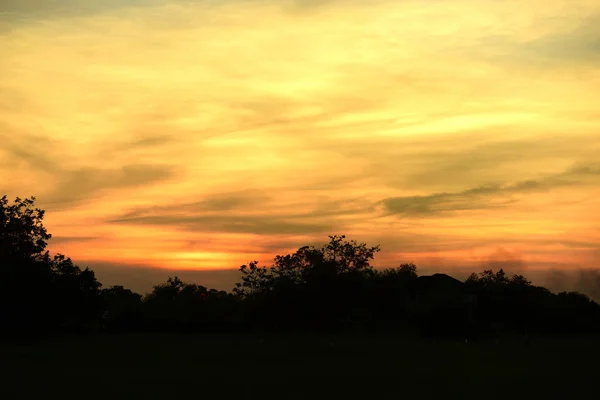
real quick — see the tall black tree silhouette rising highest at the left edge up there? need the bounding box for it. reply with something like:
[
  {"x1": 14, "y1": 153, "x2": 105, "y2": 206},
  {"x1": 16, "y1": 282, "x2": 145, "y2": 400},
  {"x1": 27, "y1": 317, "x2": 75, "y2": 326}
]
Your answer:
[{"x1": 0, "y1": 196, "x2": 102, "y2": 335}]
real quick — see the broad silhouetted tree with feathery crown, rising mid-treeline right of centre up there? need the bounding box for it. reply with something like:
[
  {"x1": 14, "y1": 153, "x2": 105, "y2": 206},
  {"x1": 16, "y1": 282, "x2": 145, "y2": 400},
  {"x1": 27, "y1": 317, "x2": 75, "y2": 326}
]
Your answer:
[{"x1": 234, "y1": 235, "x2": 379, "y2": 329}]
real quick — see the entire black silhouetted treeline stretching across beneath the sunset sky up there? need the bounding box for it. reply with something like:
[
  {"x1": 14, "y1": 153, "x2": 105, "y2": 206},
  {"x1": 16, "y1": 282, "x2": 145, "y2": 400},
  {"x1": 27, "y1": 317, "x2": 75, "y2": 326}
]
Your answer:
[{"x1": 0, "y1": 196, "x2": 600, "y2": 340}]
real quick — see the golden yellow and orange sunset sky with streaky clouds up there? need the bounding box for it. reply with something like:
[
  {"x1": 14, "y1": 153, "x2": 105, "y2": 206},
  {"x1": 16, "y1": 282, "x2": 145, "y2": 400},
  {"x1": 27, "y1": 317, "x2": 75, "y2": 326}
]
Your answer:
[{"x1": 0, "y1": 0, "x2": 600, "y2": 293}]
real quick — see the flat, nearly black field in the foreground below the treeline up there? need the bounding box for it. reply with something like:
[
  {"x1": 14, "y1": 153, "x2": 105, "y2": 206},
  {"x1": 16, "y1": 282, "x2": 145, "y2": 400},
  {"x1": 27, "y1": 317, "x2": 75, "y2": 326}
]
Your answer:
[{"x1": 0, "y1": 334, "x2": 600, "y2": 400}]
